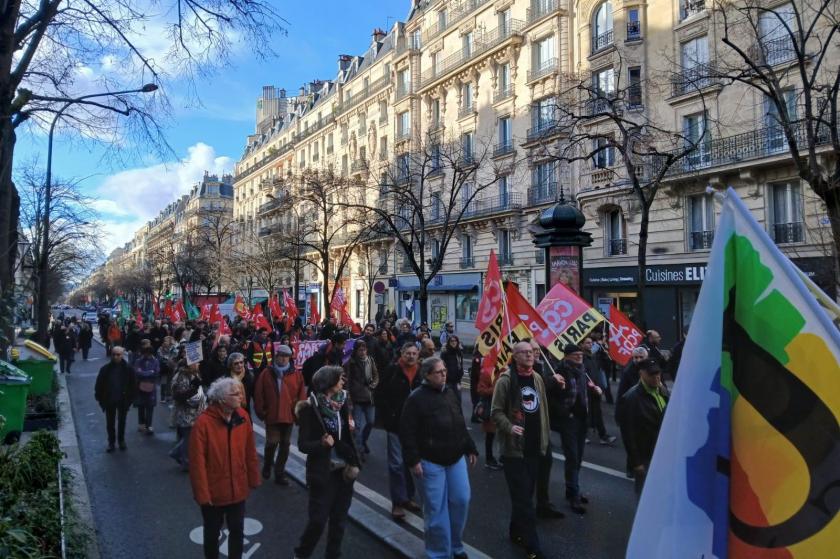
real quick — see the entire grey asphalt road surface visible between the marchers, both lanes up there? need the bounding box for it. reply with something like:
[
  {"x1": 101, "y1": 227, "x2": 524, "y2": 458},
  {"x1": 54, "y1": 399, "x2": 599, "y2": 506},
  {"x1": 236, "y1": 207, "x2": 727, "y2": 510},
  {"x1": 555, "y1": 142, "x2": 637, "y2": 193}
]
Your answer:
[{"x1": 68, "y1": 322, "x2": 636, "y2": 559}]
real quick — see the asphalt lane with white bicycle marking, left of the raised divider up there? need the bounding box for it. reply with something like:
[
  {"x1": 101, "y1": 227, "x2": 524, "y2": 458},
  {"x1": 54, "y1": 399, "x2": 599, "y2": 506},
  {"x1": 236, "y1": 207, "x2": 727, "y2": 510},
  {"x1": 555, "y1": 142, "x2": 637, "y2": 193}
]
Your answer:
[{"x1": 67, "y1": 344, "x2": 398, "y2": 559}]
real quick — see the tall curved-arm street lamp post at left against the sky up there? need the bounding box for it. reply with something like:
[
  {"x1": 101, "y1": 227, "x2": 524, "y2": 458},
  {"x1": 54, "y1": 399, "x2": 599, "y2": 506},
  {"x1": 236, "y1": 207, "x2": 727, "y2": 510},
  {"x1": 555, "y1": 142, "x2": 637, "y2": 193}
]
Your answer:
[{"x1": 37, "y1": 83, "x2": 158, "y2": 343}]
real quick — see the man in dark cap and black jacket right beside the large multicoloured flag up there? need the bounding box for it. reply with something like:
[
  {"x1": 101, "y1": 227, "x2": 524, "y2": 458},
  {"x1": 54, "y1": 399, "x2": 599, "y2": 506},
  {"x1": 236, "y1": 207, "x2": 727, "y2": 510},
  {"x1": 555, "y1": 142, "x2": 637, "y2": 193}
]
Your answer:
[{"x1": 616, "y1": 359, "x2": 669, "y2": 493}]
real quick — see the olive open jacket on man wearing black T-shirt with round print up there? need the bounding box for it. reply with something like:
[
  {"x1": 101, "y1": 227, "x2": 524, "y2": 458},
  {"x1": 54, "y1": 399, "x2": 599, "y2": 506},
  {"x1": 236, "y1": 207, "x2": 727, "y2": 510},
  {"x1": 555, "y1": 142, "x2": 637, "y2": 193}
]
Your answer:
[{"x1": 490, "y1": 369, "x2": 550, "y2": 457}]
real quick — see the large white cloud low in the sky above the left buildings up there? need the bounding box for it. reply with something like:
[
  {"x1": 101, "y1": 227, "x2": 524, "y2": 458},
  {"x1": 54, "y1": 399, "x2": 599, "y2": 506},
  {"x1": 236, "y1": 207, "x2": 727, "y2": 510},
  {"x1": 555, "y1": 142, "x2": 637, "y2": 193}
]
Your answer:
[{"x1": 94, "y1": 142, "x2": 233, "y2": 254}]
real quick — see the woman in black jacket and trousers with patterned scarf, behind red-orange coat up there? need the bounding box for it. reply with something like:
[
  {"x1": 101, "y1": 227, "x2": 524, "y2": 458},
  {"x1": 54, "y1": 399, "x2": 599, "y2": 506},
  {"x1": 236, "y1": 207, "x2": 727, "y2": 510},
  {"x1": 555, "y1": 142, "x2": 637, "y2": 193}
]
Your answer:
[{"x1": 295, "y1": 366, "x2": 360, "y2": 558}]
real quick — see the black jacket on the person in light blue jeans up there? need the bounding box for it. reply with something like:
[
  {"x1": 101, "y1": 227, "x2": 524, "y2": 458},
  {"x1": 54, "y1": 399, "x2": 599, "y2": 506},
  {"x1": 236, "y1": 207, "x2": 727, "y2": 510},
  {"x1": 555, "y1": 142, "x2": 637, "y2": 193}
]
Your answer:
[{"x1": 400, "y1": 383, "x2": 478, "y2": 467}]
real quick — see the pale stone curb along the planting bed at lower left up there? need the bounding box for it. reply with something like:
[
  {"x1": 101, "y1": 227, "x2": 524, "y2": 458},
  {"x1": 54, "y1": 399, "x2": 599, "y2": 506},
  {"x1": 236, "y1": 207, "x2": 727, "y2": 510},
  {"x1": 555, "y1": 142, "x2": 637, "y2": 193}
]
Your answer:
[{"x1": 56, "y1": 360, "x2": 100, "y2": 559}]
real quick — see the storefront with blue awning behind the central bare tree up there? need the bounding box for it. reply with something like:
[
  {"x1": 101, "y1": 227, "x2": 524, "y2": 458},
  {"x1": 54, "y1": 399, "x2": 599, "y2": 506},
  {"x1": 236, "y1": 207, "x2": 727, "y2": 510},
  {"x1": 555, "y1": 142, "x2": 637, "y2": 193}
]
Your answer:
[{"x1": 396, "y1": 273, "x2": 481, "y2": 344}]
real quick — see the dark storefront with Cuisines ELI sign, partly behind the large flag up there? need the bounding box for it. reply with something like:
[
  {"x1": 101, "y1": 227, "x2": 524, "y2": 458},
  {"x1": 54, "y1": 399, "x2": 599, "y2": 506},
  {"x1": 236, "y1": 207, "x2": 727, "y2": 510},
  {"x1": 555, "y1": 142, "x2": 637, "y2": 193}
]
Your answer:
[{"x1": 583, "y1": 258, "x2": 835, "y2": 348}]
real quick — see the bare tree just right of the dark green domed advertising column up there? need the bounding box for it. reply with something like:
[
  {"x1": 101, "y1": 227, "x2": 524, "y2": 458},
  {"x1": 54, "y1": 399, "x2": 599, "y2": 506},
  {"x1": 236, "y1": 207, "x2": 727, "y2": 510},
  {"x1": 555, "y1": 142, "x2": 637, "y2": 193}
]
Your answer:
[{"x1": 538, "y1": 63, "x2": 708, "y2": 324}]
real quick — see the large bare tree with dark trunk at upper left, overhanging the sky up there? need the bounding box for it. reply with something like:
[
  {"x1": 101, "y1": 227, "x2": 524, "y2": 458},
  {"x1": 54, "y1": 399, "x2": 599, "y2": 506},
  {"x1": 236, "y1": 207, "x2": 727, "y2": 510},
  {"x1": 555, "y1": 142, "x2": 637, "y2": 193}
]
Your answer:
[{"x1": 0, "y1": 0, "x2": 284, "y2": 296}]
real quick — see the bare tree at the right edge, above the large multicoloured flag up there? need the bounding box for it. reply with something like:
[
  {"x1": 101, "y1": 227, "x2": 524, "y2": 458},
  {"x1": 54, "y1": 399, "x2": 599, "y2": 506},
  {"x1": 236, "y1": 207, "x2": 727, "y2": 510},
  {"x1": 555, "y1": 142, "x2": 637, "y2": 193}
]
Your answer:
[{"x1": 706, "y1": 0, "x2": 840, "y2": 293}]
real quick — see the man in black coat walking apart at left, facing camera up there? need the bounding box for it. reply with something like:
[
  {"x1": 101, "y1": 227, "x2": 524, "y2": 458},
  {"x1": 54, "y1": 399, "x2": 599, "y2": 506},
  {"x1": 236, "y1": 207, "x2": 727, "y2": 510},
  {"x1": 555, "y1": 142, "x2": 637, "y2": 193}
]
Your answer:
[{"x1": 94, "y1": 346, "x2": 137, "y2": 452}]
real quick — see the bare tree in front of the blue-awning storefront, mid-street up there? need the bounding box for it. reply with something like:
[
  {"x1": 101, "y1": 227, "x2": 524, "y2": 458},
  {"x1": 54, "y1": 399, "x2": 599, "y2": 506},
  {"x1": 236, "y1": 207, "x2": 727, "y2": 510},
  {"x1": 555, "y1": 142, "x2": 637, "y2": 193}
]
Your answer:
[{"x1": 348, "y1": 134, "x2": 506, "y2": 321}]
